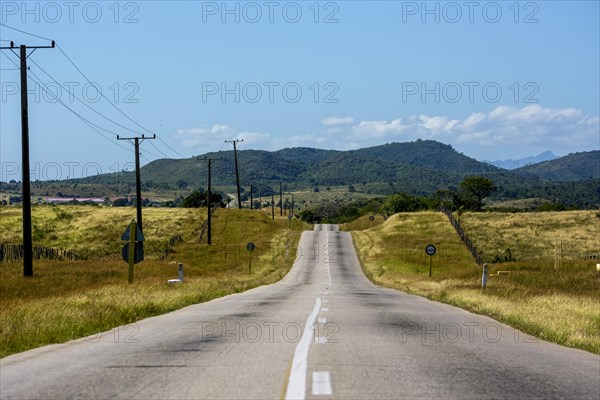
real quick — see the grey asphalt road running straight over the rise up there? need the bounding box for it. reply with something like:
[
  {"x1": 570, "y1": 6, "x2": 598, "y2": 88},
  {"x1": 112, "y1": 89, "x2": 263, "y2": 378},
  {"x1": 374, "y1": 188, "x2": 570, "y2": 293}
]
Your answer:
[{"x1": 0, "y1": 225, "x2": 600, "y2": 400}]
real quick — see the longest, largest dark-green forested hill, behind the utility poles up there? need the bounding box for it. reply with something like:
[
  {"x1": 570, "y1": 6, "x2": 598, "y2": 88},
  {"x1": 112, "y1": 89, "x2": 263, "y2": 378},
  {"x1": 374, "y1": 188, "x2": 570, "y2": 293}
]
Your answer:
[{"x1": 77, "y1": 140, "x2": 502, "y2": 193}]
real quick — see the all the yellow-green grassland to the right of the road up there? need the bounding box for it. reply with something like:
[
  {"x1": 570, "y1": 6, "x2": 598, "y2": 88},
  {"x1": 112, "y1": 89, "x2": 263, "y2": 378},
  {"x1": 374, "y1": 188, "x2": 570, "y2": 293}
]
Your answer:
[{"x1": 349, "y1": 211, "x2": 600, "y2": 354}]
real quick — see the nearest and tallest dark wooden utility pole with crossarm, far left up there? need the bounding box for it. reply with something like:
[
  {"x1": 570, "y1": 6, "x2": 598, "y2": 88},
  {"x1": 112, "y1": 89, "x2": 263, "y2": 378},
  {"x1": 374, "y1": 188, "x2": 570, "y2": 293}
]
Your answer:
[{"x1": 0, "y1": 40, "x2": 55, "y2": 276}]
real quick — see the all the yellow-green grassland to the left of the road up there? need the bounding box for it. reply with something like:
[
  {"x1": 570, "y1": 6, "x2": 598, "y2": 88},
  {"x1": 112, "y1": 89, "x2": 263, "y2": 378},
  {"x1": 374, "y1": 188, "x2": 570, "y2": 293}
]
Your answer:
[{"x1": 0, "y1": 206, "x2": 310, "y2": 357}]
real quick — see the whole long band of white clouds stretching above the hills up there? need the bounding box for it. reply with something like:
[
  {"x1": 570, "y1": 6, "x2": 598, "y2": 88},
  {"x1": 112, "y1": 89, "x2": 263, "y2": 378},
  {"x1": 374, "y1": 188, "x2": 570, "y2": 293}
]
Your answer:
[{"x1": 175, "y1": 104, "x2": 600, "y2": 159}]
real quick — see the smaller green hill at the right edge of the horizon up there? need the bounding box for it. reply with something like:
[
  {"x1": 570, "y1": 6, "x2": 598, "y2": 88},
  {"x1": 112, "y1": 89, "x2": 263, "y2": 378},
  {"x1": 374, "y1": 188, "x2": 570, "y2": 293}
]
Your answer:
[{"x1": 515, "y1": 150, "x2": 600, "y2": 182}]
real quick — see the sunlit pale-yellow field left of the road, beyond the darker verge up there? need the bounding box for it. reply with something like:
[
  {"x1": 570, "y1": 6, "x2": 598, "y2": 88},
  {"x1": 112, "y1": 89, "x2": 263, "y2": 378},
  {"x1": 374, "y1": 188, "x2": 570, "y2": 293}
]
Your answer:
[{"x1": 0, "y1": 206, "x2": 206, "y2": 258}]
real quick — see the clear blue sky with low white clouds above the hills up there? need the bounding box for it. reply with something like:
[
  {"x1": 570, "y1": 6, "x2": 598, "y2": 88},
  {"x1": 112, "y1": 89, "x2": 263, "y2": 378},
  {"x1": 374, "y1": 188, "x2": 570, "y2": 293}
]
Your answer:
[{"x1": 0, "y1": 1, "x2": 600, "y2": 180}]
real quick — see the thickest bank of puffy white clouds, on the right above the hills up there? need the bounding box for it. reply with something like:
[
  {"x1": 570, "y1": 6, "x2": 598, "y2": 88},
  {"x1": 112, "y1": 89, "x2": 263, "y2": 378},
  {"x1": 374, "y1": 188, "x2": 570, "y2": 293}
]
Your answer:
[{"x1": 346, "y1": 104, "x2": 600, "y2": 150}]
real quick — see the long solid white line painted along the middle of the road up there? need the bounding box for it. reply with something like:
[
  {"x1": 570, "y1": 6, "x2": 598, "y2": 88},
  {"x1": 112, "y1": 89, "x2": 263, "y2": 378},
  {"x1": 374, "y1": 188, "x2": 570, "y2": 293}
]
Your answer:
[{"x1": 285, "y1": 297, "x2": 321, "y2": 400}]
